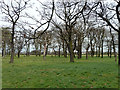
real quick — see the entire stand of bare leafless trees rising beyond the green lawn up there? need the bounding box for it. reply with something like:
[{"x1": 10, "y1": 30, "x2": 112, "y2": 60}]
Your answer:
[{"x1": 1, "y1": 0, "x2": 120, "y2": 64}]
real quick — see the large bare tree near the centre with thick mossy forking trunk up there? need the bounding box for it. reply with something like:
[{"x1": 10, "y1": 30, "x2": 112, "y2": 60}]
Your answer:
[{"x1": 53, "y1": 1, "x2": 86, "y2": 62}]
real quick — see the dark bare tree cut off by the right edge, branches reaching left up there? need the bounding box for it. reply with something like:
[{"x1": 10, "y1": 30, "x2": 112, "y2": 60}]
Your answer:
[{"x1": 87, "y1": 1, "x2": 120, "y2": 65}]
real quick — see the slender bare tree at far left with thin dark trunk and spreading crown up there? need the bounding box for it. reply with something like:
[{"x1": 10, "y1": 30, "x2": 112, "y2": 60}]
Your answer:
[{"x1": 0, "y1": 0, "x2": 28, "y2": 63}]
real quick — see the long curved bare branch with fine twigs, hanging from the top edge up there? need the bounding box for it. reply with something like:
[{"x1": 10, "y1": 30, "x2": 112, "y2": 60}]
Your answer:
[{"x1": 22, "y1": 0, "x2": 55, "y2": 40}]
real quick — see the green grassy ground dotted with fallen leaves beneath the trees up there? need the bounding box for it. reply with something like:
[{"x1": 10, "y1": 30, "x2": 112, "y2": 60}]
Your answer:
[{"x1": 2, "y1": 56, "x2": 118, "y2": 88}]
